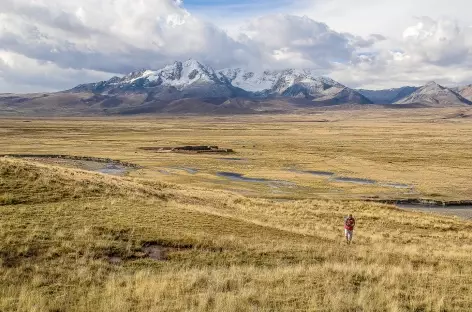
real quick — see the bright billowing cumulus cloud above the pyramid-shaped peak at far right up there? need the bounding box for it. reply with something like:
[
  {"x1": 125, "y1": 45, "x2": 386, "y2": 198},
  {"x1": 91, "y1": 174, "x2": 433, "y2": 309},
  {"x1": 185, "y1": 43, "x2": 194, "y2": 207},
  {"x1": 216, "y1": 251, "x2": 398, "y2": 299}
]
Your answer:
[{"x1": 331, "y1": 17, "x2": 472, "y2": 88}]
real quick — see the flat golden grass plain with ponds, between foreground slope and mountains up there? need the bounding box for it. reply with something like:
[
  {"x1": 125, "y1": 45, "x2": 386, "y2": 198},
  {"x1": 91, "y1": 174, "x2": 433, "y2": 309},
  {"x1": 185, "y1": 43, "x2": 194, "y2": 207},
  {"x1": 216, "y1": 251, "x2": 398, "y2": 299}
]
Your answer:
[{"x1": 0, "y1": 109, "x2": 472, "y2": 200}]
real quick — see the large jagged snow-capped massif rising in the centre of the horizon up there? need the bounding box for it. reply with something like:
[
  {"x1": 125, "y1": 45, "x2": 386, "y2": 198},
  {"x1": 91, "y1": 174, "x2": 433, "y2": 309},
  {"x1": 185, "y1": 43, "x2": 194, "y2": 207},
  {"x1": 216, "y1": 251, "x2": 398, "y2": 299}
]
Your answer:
[{"x1": 70, "y1": 60, "x2": 371, "y2": 104}]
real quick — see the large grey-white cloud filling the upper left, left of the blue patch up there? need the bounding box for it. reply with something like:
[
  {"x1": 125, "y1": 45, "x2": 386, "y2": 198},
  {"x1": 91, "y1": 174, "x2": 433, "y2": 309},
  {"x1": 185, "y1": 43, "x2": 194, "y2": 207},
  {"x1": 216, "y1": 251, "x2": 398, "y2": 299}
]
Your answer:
[{"x1": 0, "y1": 0, "x2": 254, "y2": 73}]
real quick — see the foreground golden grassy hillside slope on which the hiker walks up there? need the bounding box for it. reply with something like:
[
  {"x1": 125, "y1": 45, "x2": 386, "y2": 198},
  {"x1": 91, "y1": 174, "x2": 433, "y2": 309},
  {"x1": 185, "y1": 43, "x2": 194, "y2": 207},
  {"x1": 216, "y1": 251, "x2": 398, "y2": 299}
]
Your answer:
[{"x1": 0, "y1": 158, "x2": 472, "y2": 312}]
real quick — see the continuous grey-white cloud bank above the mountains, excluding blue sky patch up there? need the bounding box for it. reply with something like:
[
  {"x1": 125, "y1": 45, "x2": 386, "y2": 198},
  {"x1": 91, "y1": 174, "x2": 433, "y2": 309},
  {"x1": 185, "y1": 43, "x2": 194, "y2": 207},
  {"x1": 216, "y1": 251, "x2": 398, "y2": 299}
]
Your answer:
[{"x1": 0, "y1": 0, "x2": 472, "y2": 92}]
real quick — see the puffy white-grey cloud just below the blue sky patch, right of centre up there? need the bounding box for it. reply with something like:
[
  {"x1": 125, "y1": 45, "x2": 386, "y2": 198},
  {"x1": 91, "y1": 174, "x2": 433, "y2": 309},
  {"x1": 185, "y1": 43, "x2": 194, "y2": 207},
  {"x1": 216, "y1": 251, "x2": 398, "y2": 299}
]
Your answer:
[{"x1": 241, "y1": 14, "x2": 372, "y2": 71}]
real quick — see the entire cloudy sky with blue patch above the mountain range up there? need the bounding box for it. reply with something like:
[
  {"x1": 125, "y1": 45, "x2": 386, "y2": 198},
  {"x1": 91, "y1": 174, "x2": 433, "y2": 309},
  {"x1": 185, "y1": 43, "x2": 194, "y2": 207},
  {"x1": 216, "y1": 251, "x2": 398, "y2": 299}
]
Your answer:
[{"x1": 0, "y1": 0, "x2": 472, "y2": 93}]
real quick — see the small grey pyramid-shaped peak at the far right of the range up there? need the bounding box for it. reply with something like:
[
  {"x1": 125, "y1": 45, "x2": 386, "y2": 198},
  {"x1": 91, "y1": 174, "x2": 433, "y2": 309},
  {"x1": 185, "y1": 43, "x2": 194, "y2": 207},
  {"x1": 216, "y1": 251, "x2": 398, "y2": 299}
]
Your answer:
[{"x1": 395, "y1": 81, "x2": 472, "y2": 106}]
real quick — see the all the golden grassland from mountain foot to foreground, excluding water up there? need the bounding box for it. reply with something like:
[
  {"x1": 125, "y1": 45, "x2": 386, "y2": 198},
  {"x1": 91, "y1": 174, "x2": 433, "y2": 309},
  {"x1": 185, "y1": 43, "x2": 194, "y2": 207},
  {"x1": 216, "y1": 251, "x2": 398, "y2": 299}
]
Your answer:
[{"x1": 0, "y1": 106, "x2": 472, "y2": 311}]
